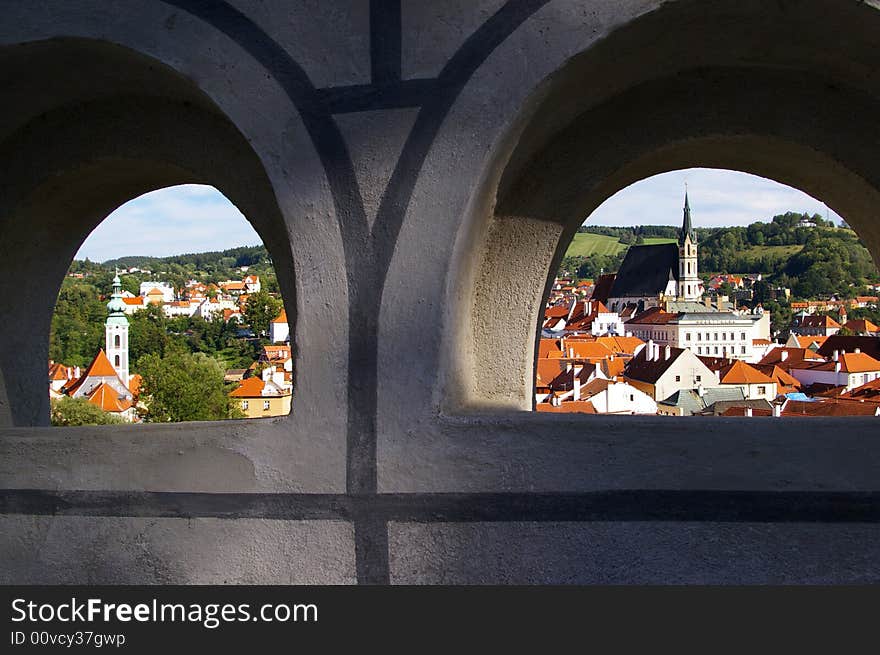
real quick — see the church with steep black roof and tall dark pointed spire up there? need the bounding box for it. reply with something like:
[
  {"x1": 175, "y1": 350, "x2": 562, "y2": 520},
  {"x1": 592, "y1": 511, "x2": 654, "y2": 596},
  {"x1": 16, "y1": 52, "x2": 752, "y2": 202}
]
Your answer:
[{"x1": 593, "y1": 192, "x2": 703, "y2": 316}]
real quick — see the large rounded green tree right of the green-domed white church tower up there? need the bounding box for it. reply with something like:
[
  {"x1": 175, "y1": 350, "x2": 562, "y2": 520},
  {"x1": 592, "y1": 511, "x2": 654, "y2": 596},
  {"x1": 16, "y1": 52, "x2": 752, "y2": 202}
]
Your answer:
[{"x1": 137, "y1": 351, "x2": 240, "y2": 423}]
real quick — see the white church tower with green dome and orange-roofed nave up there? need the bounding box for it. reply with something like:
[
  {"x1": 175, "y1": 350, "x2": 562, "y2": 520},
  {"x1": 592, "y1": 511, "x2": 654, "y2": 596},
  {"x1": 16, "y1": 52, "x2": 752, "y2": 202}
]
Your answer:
[{"x1": 61, "y1": 273, "x2": 140, "y2": 422}]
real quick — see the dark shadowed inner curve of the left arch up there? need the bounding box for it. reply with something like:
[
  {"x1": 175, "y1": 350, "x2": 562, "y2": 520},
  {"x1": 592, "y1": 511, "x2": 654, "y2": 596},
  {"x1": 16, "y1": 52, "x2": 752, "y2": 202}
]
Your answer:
[{"x1": 0, "y1": 39, "x2": 295, "y2": 425}]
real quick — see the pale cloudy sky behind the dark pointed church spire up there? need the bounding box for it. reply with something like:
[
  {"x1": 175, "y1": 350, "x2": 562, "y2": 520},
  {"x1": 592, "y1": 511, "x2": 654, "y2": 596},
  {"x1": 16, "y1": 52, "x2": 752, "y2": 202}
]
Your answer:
[{"x1": 587, "y1": 168, "x2": 841, "y2": 227}]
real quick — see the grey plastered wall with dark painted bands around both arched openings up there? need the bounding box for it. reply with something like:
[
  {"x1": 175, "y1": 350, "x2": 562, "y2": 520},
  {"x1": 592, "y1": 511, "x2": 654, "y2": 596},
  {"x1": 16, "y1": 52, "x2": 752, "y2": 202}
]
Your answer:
[{"x1": 0, "y1": 0, "x2": 880, "y2": 583}]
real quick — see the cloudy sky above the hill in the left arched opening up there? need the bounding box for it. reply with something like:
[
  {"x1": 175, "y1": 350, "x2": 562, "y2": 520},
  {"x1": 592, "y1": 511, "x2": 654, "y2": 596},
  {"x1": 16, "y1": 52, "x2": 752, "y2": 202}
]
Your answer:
[{"x1": 76, "y1": 184, "x2": 262, "y2": 261}]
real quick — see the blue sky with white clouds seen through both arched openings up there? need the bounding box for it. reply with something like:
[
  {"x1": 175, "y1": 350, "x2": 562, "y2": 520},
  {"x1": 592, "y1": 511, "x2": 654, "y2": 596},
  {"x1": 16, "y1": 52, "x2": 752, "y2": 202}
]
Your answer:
[{"x1": 76, "y1": 168, "x2": 840, "y2": 262}]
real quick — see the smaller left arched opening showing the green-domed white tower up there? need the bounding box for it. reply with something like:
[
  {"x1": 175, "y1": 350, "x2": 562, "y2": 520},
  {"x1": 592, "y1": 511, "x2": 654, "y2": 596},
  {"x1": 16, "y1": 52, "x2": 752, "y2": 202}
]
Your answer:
[{"x1": 49, "y1": 185, "x2": 293, "y2": 426}]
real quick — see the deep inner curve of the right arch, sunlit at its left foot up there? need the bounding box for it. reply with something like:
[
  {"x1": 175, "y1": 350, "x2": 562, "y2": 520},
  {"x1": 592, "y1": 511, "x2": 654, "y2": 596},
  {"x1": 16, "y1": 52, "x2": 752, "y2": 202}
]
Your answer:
[{"x1": 444, "y1": 0, "x2": 880, "y2": 411}]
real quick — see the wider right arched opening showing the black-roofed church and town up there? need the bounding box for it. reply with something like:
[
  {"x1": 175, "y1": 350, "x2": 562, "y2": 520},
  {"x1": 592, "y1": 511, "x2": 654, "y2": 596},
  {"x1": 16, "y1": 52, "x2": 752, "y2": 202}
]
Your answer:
[{"x1": 535, "y1": 169, "x2": 880, "y2": 417}]
